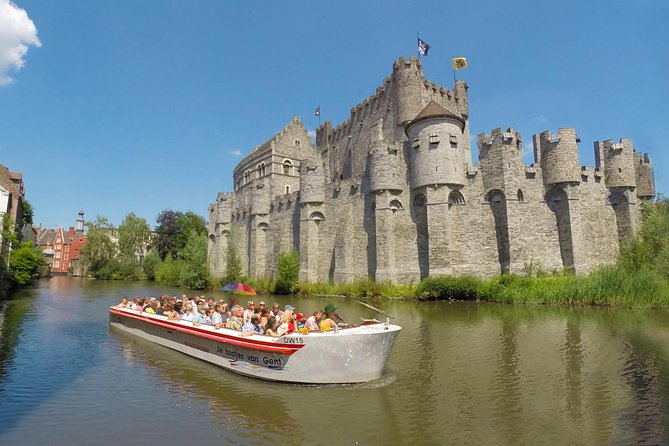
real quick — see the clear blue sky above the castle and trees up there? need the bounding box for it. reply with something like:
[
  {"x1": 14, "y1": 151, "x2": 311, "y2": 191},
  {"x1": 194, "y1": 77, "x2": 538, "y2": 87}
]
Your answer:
[{"x1": 0, "y1": 0, "x2": 669, "y2": 226}]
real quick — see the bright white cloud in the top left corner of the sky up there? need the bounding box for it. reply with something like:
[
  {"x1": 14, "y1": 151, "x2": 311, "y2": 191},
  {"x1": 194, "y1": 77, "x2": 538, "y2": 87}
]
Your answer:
[{"x1": 0, "y1": 0, "x2": 42, "y2": 86}]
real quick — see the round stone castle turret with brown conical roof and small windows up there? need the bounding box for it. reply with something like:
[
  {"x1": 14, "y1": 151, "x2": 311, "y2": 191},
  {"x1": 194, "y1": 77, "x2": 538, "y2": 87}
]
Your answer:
[{"x1": 406, "y1": 101, "x2": 466, "y2": 189}]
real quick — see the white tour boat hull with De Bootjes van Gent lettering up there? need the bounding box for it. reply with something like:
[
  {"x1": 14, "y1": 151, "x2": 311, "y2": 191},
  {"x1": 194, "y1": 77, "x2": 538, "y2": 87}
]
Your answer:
[{"x1": 109, "y1": 307, "x2": 401, "y2": 384}]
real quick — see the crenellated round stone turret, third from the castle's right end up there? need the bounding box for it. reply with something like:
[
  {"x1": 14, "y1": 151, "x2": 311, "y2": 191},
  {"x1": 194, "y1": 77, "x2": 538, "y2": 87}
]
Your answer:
[{"x1": 535, "y1": 128, "x2": 581, "y2": 184}]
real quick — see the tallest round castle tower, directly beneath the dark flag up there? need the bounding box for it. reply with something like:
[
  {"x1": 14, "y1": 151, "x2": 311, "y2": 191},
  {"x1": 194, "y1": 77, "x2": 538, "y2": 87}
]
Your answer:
[{"x1": 392, "y1": 56, "x2": 424, "y2": 125}]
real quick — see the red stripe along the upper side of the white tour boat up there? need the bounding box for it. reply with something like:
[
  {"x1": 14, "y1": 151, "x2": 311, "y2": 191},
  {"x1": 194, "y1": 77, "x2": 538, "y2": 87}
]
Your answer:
[{"x1": 109, "y1": 308, "x2": 304, "y2": 355}]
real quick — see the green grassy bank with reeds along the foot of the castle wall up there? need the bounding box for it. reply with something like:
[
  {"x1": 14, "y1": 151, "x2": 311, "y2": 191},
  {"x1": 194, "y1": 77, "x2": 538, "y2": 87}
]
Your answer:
[{"x1": 251, "y1": 199, "x2": 669, "y2": 308}]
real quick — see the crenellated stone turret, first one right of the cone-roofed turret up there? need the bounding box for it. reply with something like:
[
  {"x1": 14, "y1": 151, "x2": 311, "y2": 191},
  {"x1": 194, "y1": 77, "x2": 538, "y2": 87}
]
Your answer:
[{"x1": 477, "y1": 128, "x2": 525, "y2": 193}]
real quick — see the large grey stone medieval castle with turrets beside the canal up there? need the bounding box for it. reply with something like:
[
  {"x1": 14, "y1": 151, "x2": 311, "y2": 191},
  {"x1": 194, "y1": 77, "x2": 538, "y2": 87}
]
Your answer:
[{"x1": 209, "y1": 57, "x2": 655, "y2": 283}]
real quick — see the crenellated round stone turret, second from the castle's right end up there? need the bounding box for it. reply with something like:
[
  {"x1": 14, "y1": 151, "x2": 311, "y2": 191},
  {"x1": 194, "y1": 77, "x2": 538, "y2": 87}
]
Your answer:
[{"x1": 595, "y1": 139, "x2": 636, "y2": 187}]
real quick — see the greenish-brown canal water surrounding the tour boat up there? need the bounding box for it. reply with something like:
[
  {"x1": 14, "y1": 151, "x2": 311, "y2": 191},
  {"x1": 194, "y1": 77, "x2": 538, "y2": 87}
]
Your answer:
[{"x1": 0, "y1": 277, "x2": 669, "y2": 446}]
